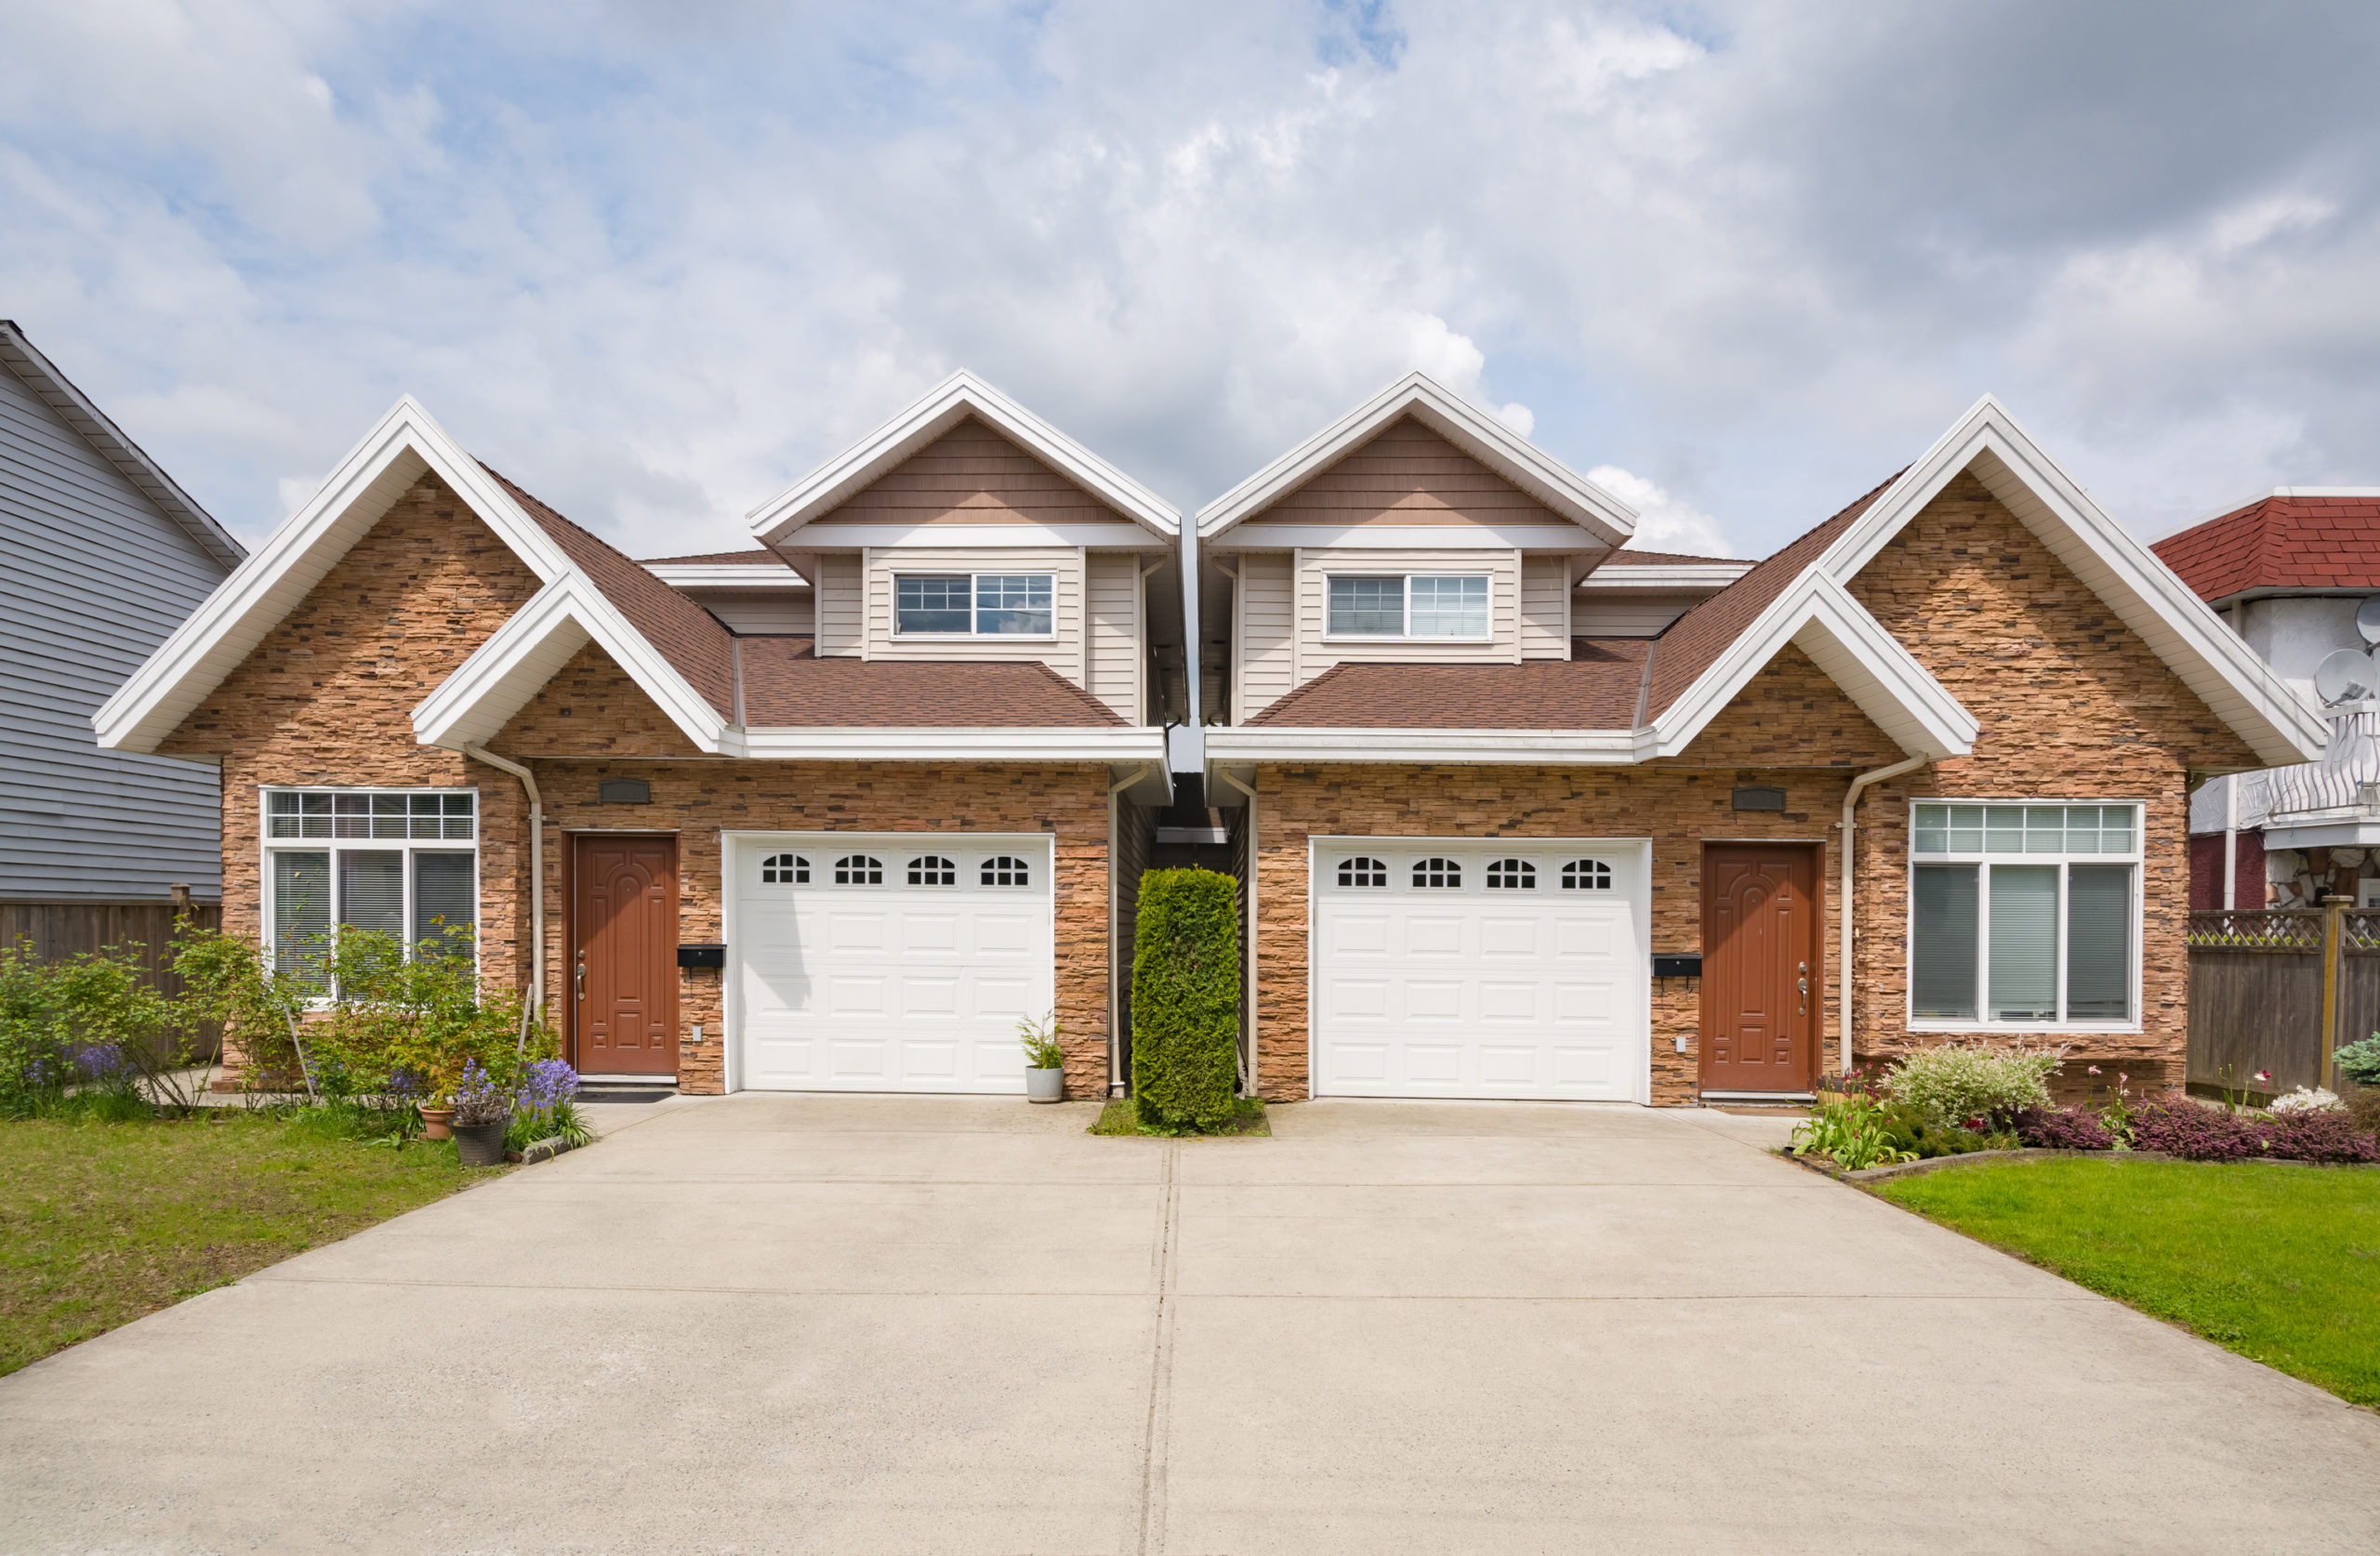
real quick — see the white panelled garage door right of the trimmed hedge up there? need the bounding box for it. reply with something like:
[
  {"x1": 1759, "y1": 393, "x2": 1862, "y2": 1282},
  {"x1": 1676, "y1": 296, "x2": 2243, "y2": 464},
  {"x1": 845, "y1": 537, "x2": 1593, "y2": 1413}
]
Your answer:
[{"x1": 1312, "y1": 837, "x2": 1649, "y2": 1101}]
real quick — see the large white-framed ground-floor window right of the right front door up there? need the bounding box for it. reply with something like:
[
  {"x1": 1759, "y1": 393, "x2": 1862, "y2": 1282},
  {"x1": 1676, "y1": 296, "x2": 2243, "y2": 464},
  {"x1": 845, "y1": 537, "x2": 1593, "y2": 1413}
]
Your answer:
[{"x1": 1909, "y1": 799, "x2": 2142, "y2": 1030}]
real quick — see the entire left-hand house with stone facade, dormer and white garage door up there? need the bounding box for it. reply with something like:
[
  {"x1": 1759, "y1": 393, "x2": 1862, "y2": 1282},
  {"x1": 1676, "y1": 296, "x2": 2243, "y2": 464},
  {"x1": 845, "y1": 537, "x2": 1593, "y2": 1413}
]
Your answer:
[{"x1": 95, "y1": 374, "x2": 1185, "y2": 1097}]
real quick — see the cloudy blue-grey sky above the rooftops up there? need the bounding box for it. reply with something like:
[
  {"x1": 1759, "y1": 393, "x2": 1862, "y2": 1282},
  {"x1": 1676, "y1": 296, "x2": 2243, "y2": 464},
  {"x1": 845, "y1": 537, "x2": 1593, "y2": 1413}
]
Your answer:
[{"x1": 0, "y1": 0, "x2": 2380, "y2": 554}]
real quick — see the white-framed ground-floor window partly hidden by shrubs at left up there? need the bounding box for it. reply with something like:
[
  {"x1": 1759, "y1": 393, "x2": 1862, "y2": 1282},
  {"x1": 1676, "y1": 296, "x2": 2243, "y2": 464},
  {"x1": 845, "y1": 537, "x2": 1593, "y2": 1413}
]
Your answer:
[{"x1": 264, "y1": 790, "x2": 479, "y2": 966}]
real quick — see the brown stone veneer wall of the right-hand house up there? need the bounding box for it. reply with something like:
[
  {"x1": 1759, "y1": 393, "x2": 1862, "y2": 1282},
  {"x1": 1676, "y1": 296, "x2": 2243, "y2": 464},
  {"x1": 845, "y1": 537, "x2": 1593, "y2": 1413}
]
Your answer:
[{"x1": 1257, "y1": 476, "x2": 2256, "y2": 1104}]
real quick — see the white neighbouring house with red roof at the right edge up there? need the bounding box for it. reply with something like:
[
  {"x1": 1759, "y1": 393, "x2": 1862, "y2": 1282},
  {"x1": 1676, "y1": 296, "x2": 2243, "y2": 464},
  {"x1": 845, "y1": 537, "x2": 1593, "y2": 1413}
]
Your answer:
[{"x1": 2151, "y1": 485, "x2": 2380, "y2": 909}]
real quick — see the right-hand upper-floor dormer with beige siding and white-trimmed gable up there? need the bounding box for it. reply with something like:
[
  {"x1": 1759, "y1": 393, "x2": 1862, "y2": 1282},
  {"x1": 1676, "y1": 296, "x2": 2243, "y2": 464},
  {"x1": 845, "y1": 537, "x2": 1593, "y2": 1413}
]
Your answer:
[{"x1": 1197, "y1": 374, "x2": 1635, "y2": 723}]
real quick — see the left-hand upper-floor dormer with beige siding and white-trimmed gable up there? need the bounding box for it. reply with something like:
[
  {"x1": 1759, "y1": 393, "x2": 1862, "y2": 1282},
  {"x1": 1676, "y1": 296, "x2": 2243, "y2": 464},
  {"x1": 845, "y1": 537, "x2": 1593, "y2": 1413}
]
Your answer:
[{"x1": 742, "y1": 374, "x2": 1183, "y2": 723}]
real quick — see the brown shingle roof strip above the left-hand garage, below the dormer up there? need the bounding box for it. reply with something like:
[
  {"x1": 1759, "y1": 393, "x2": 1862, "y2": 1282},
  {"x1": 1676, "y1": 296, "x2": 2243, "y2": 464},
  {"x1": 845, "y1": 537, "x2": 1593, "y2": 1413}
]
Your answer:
[{"x1": 740, "y1": 638, "x2": 1123, "y2": 728}]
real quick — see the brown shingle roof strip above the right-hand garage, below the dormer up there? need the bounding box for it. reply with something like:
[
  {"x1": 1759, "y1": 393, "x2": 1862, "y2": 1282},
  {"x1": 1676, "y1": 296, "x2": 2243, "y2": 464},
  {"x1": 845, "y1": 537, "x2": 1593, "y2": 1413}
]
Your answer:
[{"x1": 1250, "y1": 638, "x2": 1652, "y2": 731}]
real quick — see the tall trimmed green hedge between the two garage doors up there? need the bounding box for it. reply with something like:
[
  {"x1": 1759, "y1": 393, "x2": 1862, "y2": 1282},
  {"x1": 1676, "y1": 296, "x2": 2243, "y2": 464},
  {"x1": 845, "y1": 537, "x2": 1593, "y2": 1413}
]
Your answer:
[{"x1": 1133, "y1": 871, "x2": 1240, "y2": 1130}]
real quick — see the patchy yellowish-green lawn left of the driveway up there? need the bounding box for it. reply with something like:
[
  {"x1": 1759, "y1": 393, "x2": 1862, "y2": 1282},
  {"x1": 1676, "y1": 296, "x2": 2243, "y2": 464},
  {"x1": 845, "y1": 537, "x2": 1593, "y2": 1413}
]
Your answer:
[{"x1": 0, "y1": 1109, "x2": 507, "y2": 1373}]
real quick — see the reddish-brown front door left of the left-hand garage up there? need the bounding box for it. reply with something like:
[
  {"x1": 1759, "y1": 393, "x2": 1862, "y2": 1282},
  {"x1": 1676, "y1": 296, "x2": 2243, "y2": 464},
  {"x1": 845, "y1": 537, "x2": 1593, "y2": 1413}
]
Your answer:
[{"x1": 571, "y1": 833, "x2": 679, "y2": 1075}]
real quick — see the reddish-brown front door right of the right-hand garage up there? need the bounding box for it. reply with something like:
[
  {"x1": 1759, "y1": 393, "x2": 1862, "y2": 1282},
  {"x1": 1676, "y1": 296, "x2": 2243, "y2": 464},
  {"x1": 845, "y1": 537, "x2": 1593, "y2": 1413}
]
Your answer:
[{"x1": 1701, "y1": 842, "x2": 1826, "y2": 1092}]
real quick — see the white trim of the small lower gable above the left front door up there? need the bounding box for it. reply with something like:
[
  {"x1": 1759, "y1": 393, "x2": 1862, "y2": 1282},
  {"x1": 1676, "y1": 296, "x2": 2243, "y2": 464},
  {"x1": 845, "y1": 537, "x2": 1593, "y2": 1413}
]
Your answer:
[{"x1": 414, "y1": 574, "x2": 728, "y2": 754}]
